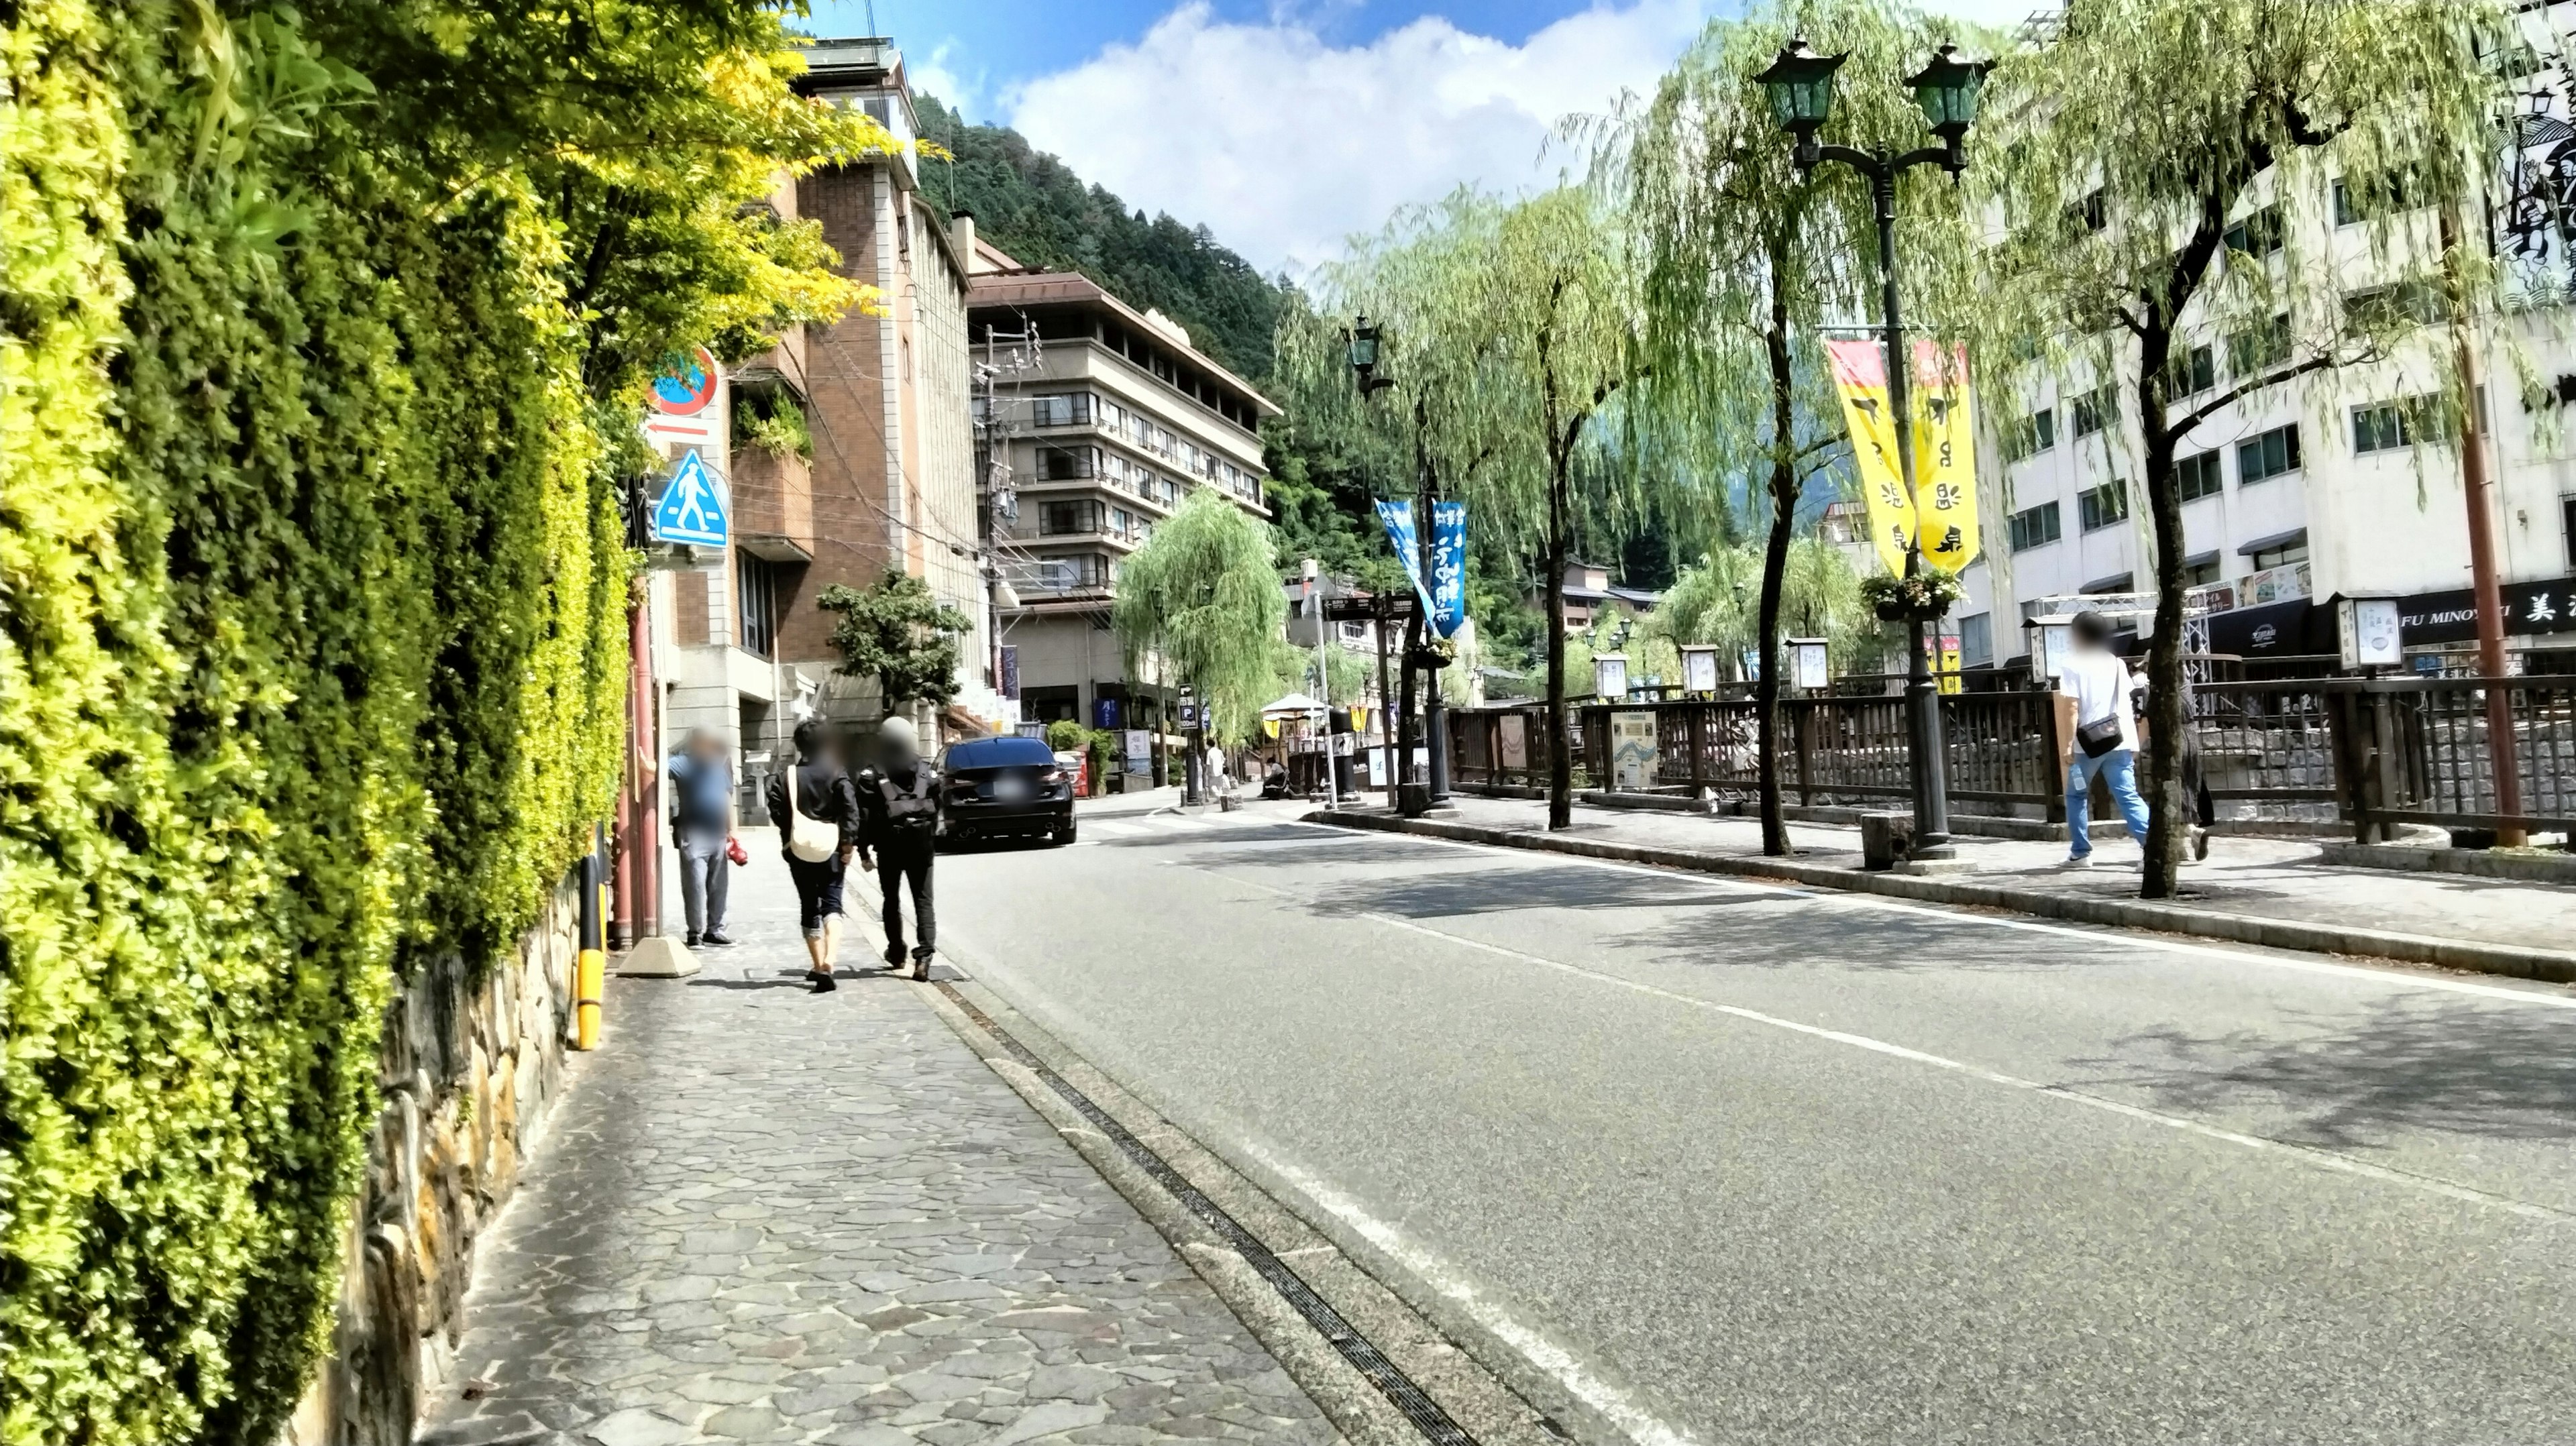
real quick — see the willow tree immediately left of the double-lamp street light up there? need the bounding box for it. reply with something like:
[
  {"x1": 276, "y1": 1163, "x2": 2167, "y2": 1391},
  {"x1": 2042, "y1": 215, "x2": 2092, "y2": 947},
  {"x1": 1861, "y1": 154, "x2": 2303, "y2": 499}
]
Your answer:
[{"x1": 1613, "y1": 0, "x2": 1953, "y2": 856}]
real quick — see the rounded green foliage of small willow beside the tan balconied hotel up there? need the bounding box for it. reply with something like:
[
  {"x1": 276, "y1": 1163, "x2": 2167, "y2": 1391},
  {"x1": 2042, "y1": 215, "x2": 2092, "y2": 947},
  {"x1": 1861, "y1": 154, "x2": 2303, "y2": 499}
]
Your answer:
[{"x1": 1110, "y1": 487, "x2": 1288, "y2": 745}]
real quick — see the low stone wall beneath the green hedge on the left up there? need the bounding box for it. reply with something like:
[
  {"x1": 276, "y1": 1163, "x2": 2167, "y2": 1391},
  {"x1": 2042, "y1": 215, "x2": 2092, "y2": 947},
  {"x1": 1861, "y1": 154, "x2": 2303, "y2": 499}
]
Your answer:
[{"x1": 278, "y1": 881, "x2": 580, "y2": 1446}]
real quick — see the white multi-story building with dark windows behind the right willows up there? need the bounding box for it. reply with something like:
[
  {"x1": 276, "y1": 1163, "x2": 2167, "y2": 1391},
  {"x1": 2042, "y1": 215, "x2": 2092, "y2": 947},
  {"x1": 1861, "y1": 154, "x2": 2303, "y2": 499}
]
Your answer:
[{"x1": 1955, "y1": 5, "x2": 2576, "y2": 667}]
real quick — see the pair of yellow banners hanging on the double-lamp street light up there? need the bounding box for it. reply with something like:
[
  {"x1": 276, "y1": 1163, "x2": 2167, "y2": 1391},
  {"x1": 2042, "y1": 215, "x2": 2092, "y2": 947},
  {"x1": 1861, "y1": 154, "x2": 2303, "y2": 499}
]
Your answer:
[{"x1": 1824, "y1": 340, "x2": 1978, "y2": 577}]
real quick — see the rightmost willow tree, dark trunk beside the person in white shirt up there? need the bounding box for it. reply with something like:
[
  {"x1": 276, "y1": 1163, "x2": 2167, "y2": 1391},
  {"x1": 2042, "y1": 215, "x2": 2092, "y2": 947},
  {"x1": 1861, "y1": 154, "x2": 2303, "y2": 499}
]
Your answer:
[{"x1": 1950, "y1": 0, "x2": 2509, "y2": 897}]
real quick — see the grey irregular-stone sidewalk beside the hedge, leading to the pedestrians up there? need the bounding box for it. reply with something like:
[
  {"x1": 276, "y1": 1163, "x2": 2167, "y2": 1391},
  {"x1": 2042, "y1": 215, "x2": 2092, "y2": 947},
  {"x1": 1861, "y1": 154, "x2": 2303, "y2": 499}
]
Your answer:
[{"x1": 420, "y1": 848, "x2": 1340, "y2": 1446}]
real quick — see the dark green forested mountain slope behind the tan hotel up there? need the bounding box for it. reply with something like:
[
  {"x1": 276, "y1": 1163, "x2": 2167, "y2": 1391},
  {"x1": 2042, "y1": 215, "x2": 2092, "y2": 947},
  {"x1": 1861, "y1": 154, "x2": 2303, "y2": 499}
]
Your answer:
[{"x1": 912, "y1": 95, "x2": 1280, "y2": 384}]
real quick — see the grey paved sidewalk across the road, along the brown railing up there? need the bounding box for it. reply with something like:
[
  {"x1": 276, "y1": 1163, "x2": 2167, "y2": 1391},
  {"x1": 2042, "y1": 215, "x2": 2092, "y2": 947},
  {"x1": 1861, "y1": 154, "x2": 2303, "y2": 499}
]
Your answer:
[{"x1": 1411, "y1": 794, "x2": 2576, "y2": 951}]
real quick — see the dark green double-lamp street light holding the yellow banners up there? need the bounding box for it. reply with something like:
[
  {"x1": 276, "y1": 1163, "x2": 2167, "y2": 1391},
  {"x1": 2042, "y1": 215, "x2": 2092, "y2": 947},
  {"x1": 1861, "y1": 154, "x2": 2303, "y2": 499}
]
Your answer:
[{"x1": 1754, "y1": 36, "x2": 1991, "y2": 858}]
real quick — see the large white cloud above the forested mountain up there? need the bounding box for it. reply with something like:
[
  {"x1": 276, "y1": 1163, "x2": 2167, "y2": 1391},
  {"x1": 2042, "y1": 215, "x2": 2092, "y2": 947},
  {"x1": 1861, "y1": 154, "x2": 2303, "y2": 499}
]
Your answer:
[{"x1": 1005, "y1": 0, "x2": 1711, "y2": 271}]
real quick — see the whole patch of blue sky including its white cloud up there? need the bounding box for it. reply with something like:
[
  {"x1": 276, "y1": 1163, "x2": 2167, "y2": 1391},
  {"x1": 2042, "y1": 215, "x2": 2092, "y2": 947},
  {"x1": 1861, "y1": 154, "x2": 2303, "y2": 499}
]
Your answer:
[{"x1": 809, "y1": 0, "x2": 2048, "y2": 276}]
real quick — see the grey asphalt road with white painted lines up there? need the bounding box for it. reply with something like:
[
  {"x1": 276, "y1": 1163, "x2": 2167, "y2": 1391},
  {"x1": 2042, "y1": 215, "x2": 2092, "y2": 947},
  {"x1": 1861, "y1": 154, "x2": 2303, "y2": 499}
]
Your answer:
[{"x1": 941, "y1": 812, "x2": 2576, "y2": 1446}]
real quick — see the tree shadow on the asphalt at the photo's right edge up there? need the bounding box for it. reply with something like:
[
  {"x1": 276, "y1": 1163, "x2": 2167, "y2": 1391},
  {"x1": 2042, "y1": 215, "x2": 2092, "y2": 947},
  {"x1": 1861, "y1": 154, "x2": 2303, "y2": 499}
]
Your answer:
[{"x1": 2071, "y1": 995, "x2": 2576, "y2": 1150}]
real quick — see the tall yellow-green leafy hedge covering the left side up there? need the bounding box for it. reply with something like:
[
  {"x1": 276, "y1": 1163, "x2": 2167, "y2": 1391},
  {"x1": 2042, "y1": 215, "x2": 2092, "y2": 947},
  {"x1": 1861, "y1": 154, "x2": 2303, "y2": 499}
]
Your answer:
[{"x1": 0, "y1": 0, "x2": 634, "y2": 1446}]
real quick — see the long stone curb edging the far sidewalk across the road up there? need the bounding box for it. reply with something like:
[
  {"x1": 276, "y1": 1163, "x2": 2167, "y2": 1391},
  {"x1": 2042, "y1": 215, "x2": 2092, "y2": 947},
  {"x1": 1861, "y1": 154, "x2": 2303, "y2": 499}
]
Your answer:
[{"x1": 1306, "y1": 810, "x2": 2576, "y2": 985}]
